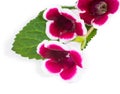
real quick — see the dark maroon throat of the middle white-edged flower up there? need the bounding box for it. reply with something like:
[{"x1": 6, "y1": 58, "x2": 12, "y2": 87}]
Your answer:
[{"x1": 56, "y1": 15, "x2": 75, "y2": 31}]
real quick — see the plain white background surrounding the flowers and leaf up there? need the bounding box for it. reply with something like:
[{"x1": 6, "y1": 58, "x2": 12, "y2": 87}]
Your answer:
[{"x1": 0, "y1": 0, "x2": 120, "y2": 94}]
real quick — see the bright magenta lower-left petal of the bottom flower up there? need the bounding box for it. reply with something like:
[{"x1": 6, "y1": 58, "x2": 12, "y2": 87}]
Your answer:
[{"x1": 45, "y1": 60, "x2": 62, "y2": 73}]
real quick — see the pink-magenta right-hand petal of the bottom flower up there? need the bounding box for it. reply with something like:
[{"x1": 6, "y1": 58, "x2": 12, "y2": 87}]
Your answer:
[{"x1": 70, "y1": 51, "x2": 82, "y2": 68}]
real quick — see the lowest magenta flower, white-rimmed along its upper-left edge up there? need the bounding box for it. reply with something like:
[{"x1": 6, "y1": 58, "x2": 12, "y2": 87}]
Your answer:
[{"x1": 37, "y1": 40, "x2": 82, "y2": 80}]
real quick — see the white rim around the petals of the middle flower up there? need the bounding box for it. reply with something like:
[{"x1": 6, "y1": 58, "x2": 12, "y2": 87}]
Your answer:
[{"x1": 43, "y1": 6, "x2": 87, "y2": 37}]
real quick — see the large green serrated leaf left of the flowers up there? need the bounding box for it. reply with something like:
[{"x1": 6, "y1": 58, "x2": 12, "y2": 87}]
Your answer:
[{"x1": 12, "y1": 11, "x2": 48, "y2": 59}]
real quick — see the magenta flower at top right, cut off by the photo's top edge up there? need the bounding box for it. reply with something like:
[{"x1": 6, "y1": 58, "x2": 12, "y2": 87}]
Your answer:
[{"x1": 77, "y1": 0, "x2": 119, "y2": 25}]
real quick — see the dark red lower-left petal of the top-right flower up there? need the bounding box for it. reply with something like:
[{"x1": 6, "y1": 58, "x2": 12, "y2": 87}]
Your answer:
[{"x1": 80, "y1": 12, "x2": 94, "y2": 24}]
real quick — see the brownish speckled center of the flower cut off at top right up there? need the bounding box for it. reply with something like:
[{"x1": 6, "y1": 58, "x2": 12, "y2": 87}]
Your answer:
[{"x1": 91, "y1": 1, "x2": 107, "y2": 16}]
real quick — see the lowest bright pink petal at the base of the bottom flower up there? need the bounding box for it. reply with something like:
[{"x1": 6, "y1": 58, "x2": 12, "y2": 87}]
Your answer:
[{"x1": 60, "y1": 66, "x2": 77, "y2": 80}]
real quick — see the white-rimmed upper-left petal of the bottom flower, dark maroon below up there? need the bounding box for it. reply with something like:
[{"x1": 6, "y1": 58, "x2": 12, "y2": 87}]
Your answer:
[{"x1": 37, "y1": 40, "x2": 68, "y2": 59}]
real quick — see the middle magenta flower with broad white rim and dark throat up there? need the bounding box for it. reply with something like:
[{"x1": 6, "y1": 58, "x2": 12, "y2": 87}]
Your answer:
[{"x1": 43, "y1": 8, "x2": 84, "y2": 41}]
